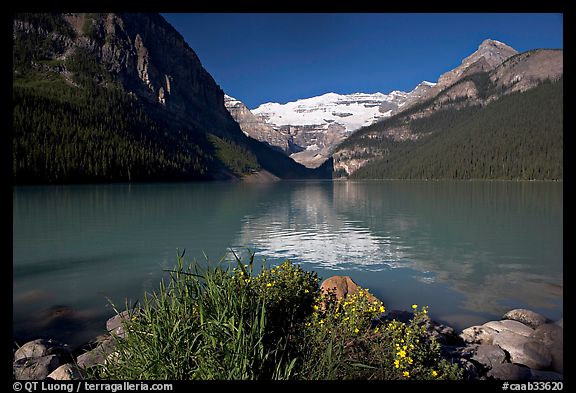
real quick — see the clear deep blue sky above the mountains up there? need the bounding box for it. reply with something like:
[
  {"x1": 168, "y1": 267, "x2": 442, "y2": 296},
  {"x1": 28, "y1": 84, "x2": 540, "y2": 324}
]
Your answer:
[{"x1": 162, "y1": 13, "x2": 564, "y2": 109}]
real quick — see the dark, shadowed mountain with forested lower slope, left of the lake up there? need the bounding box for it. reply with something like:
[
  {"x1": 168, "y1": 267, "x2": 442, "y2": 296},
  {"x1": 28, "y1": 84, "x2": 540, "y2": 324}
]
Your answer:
[{"x1": 12, "y1": 13, "x2": 322, "y2": 183}]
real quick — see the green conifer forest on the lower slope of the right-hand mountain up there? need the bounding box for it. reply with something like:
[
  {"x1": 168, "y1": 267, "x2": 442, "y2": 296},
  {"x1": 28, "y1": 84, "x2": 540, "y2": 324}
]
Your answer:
[{"x1": 342, "y1": 78, "x2": 563, "y2": 180}]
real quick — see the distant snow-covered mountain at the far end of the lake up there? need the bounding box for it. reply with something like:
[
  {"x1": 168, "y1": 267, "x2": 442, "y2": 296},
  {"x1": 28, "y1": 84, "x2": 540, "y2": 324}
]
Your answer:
[{"x1": 226, "y1": 82, "x2": 434, "y2": 168}]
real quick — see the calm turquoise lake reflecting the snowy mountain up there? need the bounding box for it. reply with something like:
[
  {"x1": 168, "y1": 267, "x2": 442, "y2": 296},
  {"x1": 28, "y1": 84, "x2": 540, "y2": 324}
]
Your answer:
[{"x1": 13, "y1": 181, "x2": 563, "y2": 345}]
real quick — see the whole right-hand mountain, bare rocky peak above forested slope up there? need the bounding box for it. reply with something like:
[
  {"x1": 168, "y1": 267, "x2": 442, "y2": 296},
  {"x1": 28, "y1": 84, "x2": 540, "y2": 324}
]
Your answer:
[{"x1": 333, "y1": 40, "x2": 563, "y2": 179}]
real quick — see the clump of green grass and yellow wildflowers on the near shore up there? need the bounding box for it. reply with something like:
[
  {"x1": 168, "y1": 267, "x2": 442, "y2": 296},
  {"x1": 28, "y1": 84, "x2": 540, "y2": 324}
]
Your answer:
[{"x1": 88, "y1": 250, "x2": 461, "y2": 380}]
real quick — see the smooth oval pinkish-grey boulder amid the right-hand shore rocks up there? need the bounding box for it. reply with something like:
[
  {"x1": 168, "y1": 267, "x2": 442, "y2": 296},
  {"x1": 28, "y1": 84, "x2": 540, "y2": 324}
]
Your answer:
[{"x1": 493, "y1": 331, "x2": 552, "y2": 370}]
